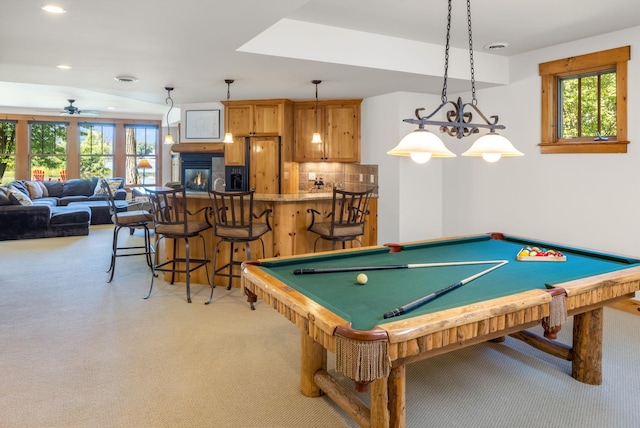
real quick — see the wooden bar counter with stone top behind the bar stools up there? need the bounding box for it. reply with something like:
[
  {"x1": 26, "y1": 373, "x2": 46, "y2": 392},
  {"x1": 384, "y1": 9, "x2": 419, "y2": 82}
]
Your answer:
[{"x1": 159, "y1": 191, "x2": 378, "y2": 287}]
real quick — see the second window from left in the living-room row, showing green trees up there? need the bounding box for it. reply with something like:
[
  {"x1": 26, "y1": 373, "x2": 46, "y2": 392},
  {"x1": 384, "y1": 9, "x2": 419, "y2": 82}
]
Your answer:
[{"x1": 29, "y1": 122, "x2": 68, "y2": 181}]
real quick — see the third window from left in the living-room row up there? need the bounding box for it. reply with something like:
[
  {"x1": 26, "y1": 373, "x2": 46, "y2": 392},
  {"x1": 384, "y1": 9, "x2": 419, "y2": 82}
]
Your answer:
[{"x1": 78, "y1": 123, "x2": 116, "y2": 178}]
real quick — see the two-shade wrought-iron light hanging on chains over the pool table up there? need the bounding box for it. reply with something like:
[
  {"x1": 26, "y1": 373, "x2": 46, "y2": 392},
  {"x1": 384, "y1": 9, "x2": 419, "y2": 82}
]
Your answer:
[{"x1": 387, "y1": 0, "x2": 523, "y2": 163}]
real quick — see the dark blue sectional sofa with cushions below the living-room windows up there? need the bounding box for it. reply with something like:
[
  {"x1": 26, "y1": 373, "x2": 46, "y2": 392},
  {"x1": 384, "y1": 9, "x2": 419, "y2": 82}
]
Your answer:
[{"x1": 0, "y1": 178, "x2": 127, "y2": 240}]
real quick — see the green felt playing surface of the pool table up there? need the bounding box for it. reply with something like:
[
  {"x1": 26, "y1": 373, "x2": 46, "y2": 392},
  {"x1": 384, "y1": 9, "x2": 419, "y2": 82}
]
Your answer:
[{"x1": 252, "y1": 234, "x2": 640, "y2": 330}]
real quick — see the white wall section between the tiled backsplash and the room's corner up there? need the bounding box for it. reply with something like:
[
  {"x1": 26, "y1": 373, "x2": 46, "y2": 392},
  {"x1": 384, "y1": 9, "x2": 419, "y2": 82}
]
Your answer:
[{"x1": 361, "y1": 92, "x2": 445, "y2": 244}]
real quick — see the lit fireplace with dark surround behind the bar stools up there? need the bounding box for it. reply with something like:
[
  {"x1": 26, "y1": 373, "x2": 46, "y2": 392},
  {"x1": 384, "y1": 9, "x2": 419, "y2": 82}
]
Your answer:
[{"x1": 180, "y1": 153, "x2": 225, "y2": 192}]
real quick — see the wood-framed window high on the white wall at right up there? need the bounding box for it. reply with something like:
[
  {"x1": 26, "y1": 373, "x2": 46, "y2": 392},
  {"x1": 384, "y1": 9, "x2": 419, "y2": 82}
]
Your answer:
[{"x1": 539, "y1": 46, "x2": 630, "y2": 154}]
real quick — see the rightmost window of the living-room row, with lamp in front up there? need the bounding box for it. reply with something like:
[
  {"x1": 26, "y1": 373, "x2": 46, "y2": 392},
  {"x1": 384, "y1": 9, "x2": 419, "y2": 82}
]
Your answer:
[{"x1": 125, "y1": 125, "x2": 160, "y2": 185}]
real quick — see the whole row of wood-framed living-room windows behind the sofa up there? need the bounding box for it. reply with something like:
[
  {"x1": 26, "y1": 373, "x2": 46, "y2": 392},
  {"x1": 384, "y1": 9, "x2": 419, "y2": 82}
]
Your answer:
[{"x1": 0, "y1": 114, "x2": 162, "y2": 186}]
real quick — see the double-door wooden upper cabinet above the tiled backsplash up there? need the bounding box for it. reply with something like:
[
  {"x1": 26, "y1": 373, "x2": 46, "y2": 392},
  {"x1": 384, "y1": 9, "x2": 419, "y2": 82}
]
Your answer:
[{"x1": 293, "y1": 100, "x2": 362, "y2": 162}]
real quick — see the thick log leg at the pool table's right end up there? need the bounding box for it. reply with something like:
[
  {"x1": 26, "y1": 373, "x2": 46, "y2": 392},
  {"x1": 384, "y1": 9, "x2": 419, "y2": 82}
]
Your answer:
[{"x1": 571, "y1": 307, "x2": 603, "y2": 385}]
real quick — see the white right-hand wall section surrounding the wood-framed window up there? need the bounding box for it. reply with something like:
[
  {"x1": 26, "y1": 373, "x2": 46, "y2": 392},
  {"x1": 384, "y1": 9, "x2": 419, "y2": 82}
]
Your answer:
[{"x1": 444, "y1": 28, "x2": 640, "y2": 255}]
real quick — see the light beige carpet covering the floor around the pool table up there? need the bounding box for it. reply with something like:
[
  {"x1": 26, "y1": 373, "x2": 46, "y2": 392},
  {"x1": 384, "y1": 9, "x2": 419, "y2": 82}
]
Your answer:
[{"x1": 0, "y1": 226, "x2": 640, "y2": 428}]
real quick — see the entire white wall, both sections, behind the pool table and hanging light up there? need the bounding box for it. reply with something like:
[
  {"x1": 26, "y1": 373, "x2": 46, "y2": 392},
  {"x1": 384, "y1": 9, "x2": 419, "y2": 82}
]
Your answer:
[{"x1": 362, "y1": 27, "x2": 640, "y2": 256}]
